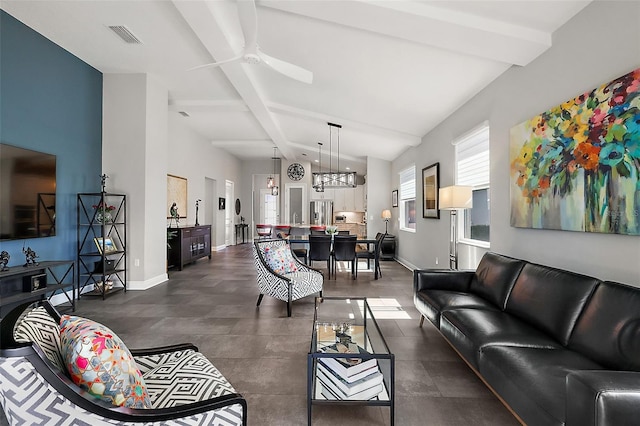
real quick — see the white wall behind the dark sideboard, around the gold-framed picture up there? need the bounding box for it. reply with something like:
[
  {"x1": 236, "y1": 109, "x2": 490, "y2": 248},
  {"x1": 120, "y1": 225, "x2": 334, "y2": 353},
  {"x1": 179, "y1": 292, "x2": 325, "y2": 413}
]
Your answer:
[{"x1": 163, "y1": 112, "x2": 241, "y2": 248}]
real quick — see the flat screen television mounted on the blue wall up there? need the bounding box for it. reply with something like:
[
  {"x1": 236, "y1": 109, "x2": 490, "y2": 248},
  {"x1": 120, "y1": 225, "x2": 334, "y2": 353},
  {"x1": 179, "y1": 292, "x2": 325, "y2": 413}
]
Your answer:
[{"x1": 0, "y1": 143, "x2": 56, "y2": 240}]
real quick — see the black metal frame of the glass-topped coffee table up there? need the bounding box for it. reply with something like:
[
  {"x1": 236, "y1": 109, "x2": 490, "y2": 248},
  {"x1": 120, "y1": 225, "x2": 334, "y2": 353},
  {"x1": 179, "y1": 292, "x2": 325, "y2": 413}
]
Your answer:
[{"x1": 307, "y1": 297, "x2": 395, "y2": 426}]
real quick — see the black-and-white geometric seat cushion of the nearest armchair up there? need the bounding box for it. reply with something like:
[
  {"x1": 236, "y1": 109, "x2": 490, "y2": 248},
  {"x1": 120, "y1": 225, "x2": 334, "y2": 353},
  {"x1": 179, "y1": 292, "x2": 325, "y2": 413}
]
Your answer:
[{"x1": 144, "y1": 351, "x2": 236, "y2": 408}]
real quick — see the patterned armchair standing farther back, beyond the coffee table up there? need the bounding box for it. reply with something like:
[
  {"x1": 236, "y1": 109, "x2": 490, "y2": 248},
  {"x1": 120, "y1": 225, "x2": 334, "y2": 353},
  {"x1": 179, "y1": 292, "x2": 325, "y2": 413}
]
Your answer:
[{"x1": 253, "y1": 240, "x2": 324, "y2": 317}]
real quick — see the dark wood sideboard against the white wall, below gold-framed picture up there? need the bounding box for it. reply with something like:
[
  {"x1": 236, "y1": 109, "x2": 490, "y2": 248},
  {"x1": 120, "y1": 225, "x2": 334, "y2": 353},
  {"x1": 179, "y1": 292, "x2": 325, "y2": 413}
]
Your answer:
[{"x1": 167, "y1": 225, "x2": 211, "y2": 271}]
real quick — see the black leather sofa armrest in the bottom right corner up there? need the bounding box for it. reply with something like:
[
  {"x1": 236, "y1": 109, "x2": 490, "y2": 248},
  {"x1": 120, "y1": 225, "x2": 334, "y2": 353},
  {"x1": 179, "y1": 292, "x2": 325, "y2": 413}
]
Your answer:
[{"x1": 565, "y1": 370, "x2": 640, "y2": 426}]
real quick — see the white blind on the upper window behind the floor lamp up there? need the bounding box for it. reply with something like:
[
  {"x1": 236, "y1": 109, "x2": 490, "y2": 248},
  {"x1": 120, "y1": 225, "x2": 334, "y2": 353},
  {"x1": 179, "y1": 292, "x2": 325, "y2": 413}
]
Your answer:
[{"x1": 454, "y1": 126, "x2": 489, "y2": 187}]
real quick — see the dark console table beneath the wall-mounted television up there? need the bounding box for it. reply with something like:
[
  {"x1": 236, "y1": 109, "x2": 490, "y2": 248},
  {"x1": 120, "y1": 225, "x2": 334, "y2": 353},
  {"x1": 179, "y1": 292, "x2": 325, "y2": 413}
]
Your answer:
[{"x1": 0, "y1": 260, "x2": 76, "y2": 317}]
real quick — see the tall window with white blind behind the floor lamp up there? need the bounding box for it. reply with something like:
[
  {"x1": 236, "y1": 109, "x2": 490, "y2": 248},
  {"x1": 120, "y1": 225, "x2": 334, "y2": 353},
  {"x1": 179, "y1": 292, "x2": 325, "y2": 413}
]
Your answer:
[{"x1": 454, "y1": 123, "x2": 491, "y2": 246}]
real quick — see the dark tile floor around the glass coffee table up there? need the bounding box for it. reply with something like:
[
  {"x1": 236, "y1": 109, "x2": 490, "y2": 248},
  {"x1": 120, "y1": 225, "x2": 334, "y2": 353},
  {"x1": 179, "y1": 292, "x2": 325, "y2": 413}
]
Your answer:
[{"x1": 0, "y1": 244, "x2": 518, "y2": 426}]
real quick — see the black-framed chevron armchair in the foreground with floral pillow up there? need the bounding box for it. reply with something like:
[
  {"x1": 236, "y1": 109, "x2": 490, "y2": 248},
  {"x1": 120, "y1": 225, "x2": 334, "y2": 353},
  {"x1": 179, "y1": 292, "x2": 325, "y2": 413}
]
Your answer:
[{"x1": 0, "y1": 302, "x2": 247, "y2": 426}]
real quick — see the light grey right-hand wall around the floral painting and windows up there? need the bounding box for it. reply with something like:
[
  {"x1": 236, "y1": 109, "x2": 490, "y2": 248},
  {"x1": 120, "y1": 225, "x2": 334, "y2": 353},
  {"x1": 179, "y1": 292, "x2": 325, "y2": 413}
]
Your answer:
[{"x1": 391, "y1": 1, "x2": 640, "y2": 286}]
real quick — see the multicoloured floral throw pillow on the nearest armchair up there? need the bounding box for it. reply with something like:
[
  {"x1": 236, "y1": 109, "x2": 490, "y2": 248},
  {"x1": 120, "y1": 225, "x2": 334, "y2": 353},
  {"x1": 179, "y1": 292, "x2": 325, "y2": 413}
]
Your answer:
[{"x1": 60, "y1": 315, "x2": 151, "y2": 408}]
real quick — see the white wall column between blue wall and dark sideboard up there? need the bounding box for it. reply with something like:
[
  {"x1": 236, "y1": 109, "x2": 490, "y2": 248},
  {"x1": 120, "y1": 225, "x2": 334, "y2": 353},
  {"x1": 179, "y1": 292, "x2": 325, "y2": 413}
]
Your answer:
[{"x1": 102, "y1": 74, "x2": 168, "y2": 289}]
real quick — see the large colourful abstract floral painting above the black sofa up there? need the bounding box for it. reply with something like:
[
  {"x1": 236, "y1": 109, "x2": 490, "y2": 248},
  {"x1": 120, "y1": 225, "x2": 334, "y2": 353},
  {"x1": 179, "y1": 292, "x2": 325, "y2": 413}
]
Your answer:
[{"x1": 510, "y1": 69, "x2": 640, "y2": 235}]
